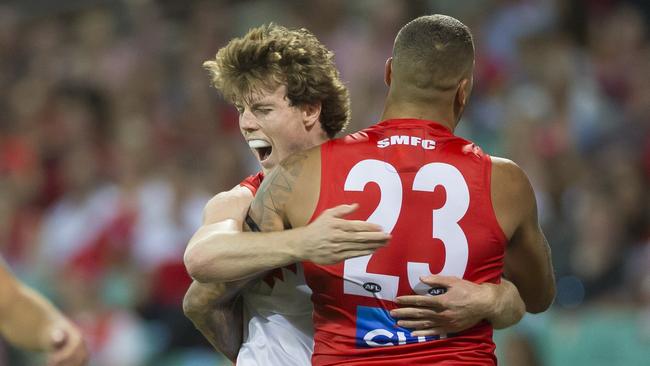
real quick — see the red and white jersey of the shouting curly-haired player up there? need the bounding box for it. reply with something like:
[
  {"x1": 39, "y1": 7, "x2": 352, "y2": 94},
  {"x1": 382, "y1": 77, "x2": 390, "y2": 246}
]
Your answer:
[{"x1": 237, "y1": 173, "x2": 314, "y2": 366}]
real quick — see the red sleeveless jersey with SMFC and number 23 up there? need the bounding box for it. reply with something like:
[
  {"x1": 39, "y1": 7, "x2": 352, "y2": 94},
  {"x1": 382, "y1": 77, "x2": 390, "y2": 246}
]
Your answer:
[{"x1": 304, "y1": 119, "x2": 506, "y2": 366}]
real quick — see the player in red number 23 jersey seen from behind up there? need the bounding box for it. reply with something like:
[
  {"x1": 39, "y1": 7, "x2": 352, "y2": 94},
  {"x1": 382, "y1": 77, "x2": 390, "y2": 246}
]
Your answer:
[{"x1": 250, "y1": 15, "x2": 555, "y2": 365}]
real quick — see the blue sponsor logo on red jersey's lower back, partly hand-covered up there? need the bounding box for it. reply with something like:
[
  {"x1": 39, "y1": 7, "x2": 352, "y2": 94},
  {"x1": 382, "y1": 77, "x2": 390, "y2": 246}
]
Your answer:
[{"x1": 356, "y1": 306, "x2": 439, "y2": 348}]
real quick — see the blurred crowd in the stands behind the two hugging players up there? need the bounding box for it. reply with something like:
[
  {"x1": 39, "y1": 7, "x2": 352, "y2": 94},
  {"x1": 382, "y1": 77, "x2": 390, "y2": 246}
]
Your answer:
[{"x1": 0, "y1": 0, "x2": 650, "y2": 366}]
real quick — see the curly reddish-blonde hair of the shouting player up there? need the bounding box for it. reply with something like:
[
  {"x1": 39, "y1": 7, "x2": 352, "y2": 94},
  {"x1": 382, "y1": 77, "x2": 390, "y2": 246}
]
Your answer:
[{"x1": 203, "y1": 23, "x2": 350, "y2": 138}]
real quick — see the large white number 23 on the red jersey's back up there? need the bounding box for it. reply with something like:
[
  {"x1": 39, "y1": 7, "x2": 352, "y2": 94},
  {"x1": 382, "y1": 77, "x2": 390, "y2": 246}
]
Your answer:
[{"x1": 343, "y1": 159, "x2": 469, "y2": 301}]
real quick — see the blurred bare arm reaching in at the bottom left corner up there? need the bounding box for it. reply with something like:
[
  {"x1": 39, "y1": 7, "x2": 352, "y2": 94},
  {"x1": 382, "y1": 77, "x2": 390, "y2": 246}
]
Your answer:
[{"x1": 0, "y1": 260, "x2": 87, "y2": 365}]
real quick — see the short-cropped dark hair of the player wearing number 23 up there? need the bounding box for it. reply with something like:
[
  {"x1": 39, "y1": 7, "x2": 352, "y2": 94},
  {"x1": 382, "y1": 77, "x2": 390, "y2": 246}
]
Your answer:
[{"x1": 392, "y1": 14, "x2": 474, "y2": 90}]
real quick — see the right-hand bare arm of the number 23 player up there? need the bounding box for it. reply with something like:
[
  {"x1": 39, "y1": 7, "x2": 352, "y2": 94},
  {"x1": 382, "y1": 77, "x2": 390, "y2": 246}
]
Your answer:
[{"x1": 492, "y1": 158, "x2": 555, "y2": 313}]
